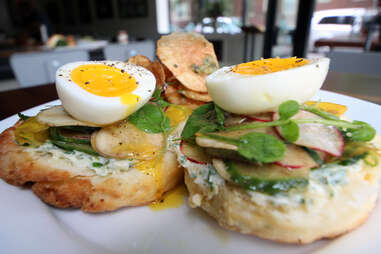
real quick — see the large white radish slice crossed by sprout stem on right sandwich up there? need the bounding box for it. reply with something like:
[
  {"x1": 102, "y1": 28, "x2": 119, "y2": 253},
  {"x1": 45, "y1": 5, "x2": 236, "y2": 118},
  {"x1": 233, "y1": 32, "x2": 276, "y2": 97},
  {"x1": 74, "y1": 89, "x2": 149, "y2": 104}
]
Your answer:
[{"x1": 273, "y1": 110, "x2": 344, "y2": 157}]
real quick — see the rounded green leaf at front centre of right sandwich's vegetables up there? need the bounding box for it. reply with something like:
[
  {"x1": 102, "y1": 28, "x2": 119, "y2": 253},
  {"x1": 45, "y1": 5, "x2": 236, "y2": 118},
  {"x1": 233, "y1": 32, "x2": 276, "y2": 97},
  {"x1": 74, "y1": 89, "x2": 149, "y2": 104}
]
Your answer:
[{"x1": 238, "y1": 132, "x2": 286, "y2": 163}]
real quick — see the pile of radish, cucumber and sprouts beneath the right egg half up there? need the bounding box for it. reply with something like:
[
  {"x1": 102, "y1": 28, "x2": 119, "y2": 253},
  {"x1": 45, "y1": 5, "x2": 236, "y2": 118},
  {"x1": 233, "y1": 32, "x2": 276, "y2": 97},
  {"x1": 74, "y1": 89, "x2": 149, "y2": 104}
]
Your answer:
[{"x1": 181, "y1": 100, "x2": 378, "y2": 194}]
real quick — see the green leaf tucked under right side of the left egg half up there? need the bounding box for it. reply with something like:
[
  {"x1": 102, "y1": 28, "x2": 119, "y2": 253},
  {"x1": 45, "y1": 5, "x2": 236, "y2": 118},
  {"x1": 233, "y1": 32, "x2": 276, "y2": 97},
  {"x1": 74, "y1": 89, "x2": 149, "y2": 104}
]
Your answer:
[{"x1": 128, "y1": 103, "x2": 170, "y2": 133}]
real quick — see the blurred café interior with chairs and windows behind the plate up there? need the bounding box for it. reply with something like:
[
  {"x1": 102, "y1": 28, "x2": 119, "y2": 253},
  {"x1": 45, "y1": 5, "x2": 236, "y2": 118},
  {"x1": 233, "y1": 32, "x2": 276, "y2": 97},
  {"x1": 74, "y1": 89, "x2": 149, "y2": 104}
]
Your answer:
[{"x1": 0, "y1": 0, "x2": 381, "y2": 104}]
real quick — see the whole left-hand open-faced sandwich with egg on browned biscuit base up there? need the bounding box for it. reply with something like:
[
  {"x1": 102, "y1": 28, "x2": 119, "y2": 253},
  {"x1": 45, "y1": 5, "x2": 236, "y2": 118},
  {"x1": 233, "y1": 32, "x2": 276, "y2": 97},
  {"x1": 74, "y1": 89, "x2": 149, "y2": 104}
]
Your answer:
[{"x1": 0, "y1": 61, "x2": 189, "y2": 212}]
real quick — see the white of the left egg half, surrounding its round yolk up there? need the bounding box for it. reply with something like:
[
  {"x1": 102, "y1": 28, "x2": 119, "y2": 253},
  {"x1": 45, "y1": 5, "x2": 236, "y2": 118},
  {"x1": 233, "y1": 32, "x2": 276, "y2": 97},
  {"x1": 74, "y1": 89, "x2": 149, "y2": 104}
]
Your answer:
[{"x1": 56, "y1": 61, "x2": 156, "y2": 125}]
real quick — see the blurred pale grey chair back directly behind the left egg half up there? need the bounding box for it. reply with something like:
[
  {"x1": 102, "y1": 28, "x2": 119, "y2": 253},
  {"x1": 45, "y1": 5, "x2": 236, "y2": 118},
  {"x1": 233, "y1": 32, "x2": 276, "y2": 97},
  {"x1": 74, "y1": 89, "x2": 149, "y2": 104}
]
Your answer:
[{"x1": 104, "y1": 41, "x2": 155, "y2": 61}]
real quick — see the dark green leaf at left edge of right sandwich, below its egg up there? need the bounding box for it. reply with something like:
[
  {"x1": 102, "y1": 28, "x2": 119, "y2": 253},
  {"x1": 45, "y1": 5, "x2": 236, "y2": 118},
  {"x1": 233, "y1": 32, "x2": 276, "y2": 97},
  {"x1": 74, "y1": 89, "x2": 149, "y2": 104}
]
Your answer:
[{"x1": 181, "y1": 103, "x2": 219, "y2": 142}]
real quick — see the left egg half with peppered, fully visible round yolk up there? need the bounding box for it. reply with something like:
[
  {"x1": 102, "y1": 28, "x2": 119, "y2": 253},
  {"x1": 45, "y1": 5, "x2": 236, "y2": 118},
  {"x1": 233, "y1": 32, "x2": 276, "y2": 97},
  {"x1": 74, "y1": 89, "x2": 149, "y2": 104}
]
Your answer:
[{"x1": 56, "y1": 61, "x2": 156, "y2": 125}]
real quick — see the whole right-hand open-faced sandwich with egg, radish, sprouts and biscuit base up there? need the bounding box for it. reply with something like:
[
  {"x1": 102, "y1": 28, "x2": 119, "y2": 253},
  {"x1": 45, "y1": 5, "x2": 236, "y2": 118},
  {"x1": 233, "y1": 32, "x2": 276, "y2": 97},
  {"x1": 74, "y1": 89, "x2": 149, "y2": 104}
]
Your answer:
[{"x1": 177, "y1": 58, "x2": 381, "y2": 244}]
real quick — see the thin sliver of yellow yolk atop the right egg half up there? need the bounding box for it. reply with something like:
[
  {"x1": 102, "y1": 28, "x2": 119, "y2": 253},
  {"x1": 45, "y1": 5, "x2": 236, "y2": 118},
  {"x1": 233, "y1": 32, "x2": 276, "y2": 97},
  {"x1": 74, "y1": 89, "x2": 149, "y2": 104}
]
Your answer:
[{"x1": 232, "y1": 57, "x2": 310, "y2": 75}]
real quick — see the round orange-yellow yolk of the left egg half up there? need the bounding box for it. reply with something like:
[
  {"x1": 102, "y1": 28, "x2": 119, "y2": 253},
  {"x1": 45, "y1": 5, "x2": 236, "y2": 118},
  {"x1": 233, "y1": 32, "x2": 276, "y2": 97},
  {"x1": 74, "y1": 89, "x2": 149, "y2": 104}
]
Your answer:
[{"x1": 71, "y1": 64, "x2": 138, "y2": 97}]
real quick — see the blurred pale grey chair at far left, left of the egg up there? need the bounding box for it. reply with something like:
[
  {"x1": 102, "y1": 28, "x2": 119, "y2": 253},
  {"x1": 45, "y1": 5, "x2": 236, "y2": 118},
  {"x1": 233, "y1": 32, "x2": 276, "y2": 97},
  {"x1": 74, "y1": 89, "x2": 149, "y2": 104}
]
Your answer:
[{"x1": 10, "y1": 50, "x2": 89, "y2": 87}]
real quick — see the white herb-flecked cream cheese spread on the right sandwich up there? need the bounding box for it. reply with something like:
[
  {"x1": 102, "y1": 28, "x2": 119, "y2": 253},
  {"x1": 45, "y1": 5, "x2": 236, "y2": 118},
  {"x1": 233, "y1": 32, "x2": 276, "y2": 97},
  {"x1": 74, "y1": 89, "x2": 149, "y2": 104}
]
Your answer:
[{"x1": 171, "y1": 137, "x2": 371, "y2": 209}]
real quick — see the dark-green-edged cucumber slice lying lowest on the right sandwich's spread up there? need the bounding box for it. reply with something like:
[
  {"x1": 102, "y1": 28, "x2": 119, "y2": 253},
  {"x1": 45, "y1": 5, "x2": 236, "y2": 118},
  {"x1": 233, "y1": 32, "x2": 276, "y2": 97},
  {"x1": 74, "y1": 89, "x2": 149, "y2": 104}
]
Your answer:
[{"x1": 213, "y1": 159, "x2": 310, "y2": 195}]
